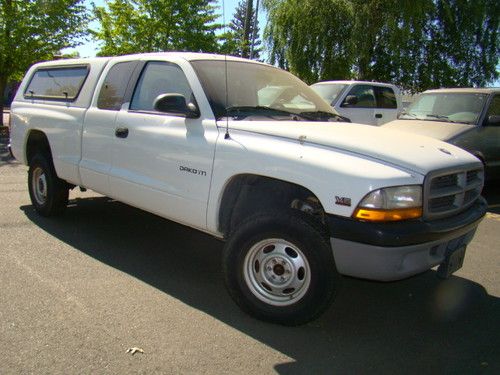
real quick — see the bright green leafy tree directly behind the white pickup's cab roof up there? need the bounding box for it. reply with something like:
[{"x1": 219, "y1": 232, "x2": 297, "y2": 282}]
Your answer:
[{"x1": 92, "y1": 0, "x2": 221, "y2": 56}]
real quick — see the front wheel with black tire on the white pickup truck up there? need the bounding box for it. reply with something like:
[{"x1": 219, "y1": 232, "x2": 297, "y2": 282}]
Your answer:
[{"x1": 223, "y1": 210, "x2": 339, "y2": 325}]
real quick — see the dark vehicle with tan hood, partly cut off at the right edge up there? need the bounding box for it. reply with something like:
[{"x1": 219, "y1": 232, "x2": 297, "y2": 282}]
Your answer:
[{"x1": 383, "y1": 88, "x2": 500, "y2": 180}]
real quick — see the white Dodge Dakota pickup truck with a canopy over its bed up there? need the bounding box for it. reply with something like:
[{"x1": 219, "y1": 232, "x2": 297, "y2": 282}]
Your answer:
[{"x1": 11, "y1": 53, "x2": 486, "y2": 325}]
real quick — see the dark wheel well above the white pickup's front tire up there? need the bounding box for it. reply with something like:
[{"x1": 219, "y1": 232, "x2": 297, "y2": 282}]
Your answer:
[{"x1": 219, "y1": 174, "x2": 325, "y2": 237}]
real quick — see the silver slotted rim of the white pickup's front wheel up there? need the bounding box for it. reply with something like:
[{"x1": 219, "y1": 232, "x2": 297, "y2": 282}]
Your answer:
[{"x1": 244, "y1": 238, "x2": 311, "y2": 306}]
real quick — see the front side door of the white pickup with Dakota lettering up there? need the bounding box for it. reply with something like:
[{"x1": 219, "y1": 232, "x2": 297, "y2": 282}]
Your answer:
[{"x1": 110, "y1": 61, "x2": 218, "y2": 229}]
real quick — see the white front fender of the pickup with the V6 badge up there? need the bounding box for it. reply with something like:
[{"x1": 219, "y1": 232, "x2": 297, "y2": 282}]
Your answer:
[{"x1": 207, "y1": 130, "x2": 423, "y2": 232}]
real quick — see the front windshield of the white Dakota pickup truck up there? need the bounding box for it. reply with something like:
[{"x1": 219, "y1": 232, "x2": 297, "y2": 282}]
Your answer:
[{"x1": 191, "y1": 60, "x2": 338, "y2": 121}]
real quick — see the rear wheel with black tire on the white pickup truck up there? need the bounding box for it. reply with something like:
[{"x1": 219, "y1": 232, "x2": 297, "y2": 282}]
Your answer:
[{"x1": 28, "y1": 154, "x2": 69, "y2": 216}]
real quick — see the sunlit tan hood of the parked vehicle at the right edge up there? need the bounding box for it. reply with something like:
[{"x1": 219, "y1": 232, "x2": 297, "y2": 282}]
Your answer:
[{"x1": 382, "y1": 120, "x2": 475, "y2": 141}]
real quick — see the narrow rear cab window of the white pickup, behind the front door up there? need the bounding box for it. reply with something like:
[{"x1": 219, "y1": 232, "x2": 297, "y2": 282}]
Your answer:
[{"x1": 97, "y1": 61, "x2": 137, "y2": 111}]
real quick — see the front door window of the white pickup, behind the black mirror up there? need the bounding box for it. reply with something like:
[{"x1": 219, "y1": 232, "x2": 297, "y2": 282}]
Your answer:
[{"x1": 130, "y1": 61, "x2": 193, "y2": 112}]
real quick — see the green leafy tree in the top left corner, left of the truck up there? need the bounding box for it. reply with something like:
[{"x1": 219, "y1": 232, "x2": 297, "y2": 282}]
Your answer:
[{"x1": 0, "y1": 0, "x2": 88, "y2": 125}]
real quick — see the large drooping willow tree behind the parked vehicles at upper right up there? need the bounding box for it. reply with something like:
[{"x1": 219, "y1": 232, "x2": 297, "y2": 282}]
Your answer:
[{"x1": 264, "y1": 0, "x2": 500, "y2": 91}]
